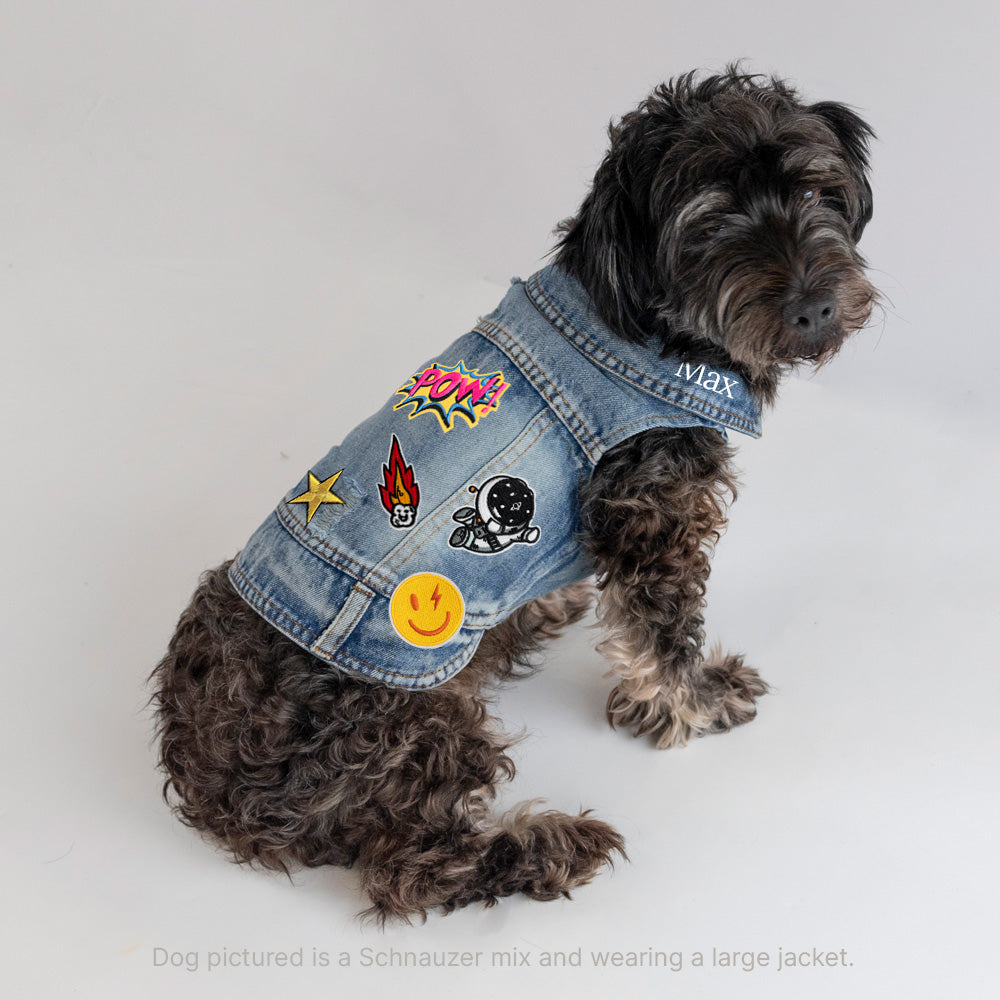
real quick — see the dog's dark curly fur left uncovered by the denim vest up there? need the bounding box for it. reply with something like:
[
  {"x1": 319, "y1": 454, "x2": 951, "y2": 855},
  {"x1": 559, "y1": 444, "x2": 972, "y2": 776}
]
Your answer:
[{"x1": 153, "y1": 66, "x2": 876, "y2": 920}]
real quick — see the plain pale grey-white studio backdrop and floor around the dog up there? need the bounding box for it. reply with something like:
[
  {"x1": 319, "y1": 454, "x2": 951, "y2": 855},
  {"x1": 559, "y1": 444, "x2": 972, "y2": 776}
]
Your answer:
[{"x1": 0, "y1": 0, "x2": 1000, "y2": 998}]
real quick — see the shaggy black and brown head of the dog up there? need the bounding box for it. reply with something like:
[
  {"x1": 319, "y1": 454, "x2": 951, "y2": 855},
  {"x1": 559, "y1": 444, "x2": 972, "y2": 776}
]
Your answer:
[{"x1": 556, "y1": 66, "x2": 876, "y2": 395}]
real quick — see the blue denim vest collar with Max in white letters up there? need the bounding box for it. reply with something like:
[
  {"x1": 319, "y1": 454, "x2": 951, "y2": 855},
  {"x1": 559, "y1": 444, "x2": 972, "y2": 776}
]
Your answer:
[{"x1": 525, "y1": 264, "x2": 761, "y2": 437}]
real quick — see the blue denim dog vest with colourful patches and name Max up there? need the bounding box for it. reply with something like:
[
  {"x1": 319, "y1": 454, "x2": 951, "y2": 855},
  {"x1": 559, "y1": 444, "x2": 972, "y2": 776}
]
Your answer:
[{"x1": 229, "y1": 266, "x2": 760, "y2": 688}]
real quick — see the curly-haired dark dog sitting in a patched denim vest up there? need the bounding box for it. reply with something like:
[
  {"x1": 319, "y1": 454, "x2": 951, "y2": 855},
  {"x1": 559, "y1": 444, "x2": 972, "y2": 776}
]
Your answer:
[{"x1": 154, "y1": 67, "x2": 876, "y2": 920}]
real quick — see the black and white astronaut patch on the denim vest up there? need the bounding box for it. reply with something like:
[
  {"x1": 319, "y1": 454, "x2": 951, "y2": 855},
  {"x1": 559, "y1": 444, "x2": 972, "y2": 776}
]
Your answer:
[{"x1": 448, "y1": 476, "x2": 541, "y2": 555}]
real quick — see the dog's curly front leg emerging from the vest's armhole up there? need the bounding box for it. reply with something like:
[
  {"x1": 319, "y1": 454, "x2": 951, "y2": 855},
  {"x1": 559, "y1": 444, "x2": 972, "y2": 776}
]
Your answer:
[{"x1": 582, "y1": 429, "x2": 767, "y2": 747}]
